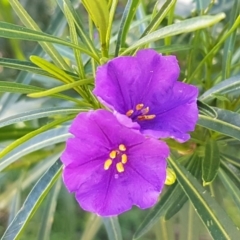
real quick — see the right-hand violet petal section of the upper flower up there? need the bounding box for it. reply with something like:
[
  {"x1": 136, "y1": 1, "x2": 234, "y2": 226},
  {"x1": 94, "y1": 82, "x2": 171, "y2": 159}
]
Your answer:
[{"x1": 141, "y1": 82, "x2": 198, "y2": 142}]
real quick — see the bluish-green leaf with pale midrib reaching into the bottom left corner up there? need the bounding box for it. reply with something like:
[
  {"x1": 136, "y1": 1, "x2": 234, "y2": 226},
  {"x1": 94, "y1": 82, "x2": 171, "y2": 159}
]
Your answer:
[{"x1": 1, "y1": 160, "x2": 62, "y2": 240}]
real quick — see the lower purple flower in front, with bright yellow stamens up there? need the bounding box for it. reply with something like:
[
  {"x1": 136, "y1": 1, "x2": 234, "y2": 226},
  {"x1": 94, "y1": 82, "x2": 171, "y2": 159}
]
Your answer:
[{"x1": 61, "y1": 110, "x2": 169, "y2": 216}]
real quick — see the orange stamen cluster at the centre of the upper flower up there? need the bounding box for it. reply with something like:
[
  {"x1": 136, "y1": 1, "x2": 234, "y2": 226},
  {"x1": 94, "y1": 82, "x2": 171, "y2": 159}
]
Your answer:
[{"x1": 126, "y1": 103, "x2": 156, "y2": 121}]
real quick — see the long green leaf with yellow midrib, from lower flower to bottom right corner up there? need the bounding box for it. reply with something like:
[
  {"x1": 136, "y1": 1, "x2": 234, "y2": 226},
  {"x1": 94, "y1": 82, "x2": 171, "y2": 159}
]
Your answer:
[{"x1": 169, "y1": 158, "x2": 240, "y2": 240}]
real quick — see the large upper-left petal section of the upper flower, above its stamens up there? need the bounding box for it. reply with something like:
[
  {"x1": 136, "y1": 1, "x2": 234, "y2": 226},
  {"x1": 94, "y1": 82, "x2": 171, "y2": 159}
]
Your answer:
[{"x1": 93, "y1": 49, "x2": 179, "y2": 114}]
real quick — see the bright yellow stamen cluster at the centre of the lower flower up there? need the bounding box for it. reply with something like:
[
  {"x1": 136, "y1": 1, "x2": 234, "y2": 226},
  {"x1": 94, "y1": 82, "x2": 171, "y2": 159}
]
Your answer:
[{"x1": 103, "y1": 144, "x2": 127, "y2": 173}]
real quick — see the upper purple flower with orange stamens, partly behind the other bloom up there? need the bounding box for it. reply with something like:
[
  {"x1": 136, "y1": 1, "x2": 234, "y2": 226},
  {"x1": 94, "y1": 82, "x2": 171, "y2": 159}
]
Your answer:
[{"x1": 93, "y1": 49, "x2": 198, "y2": 142}]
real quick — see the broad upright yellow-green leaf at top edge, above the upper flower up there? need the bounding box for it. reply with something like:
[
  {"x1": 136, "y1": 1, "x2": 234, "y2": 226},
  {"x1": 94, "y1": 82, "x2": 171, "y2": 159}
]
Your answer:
[{"x1": 82, "y1": 0, "x2": 109, "y2": 57}]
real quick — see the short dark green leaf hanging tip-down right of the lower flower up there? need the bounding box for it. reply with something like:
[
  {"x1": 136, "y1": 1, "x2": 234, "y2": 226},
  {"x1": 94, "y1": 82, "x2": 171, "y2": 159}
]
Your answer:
[{"x1": 202, "y1": 140, "x2": 220, "y2": 186}]
